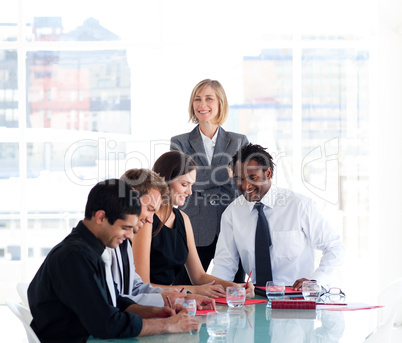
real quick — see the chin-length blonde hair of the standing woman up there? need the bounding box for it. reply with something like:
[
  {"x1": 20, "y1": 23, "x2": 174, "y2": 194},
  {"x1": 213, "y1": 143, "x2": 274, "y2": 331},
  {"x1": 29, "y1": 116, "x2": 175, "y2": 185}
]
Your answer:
[{"x1": 188, "y1": 79, "x2": 229, "y2": 126}]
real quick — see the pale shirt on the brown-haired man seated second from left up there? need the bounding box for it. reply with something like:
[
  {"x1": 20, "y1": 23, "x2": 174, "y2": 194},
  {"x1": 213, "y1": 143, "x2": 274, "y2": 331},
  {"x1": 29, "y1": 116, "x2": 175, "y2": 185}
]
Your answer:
[{"x1": 106, "y1": 243, "x2": 164, "y2": 307}]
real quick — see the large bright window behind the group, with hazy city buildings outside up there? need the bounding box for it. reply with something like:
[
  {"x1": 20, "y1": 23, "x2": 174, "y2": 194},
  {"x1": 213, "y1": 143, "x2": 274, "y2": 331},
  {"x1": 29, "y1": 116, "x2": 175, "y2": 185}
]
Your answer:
[{"x1": 0, "y1": 0, "x2": 400, "y2": 310}]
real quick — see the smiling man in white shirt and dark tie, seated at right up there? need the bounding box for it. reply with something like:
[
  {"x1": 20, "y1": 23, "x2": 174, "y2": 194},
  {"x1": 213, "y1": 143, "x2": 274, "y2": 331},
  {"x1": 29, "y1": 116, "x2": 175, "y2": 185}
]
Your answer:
[{"x1": 212, "y1": 143, "x2": 345, "y2": 290}]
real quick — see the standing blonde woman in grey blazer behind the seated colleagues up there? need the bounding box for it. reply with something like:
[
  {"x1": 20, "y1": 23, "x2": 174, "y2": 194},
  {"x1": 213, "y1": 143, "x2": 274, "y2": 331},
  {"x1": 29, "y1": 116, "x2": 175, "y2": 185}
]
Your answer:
[{"x1": 170, "y1": 79, "x2": 248, "y2": 284}]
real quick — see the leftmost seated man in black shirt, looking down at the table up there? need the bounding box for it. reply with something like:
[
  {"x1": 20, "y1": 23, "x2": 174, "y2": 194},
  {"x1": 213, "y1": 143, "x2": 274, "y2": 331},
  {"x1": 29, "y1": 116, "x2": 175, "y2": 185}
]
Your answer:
[{"x1": 28, "y1": 179, "x2": 198, "y2": 343}]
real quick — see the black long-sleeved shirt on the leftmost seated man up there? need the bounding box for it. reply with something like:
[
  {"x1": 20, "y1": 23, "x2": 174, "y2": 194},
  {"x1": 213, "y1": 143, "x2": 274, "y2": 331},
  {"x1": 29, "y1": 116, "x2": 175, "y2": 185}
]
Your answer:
[{"x1": 28, "y1": 222, "x2": 142, "y2": 343}]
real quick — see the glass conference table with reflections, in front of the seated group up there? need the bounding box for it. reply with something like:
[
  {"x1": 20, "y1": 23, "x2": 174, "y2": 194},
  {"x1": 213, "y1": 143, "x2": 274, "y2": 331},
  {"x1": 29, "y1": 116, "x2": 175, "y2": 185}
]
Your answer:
[{"x1": 88, "y1": 296, "x2": 382, "y2": 343}]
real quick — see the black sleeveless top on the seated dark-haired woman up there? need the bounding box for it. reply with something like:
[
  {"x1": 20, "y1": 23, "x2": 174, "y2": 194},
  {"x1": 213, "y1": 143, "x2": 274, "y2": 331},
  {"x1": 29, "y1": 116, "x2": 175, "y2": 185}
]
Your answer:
[{"x1": 150, "y1": 208, "x2": 188, "y2": 285}]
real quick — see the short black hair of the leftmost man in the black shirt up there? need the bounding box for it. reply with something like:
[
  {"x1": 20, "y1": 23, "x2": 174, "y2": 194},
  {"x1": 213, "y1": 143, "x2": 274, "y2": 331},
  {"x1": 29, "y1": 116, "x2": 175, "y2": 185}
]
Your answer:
[{"x1": 85, "y1": 179, "x2": 141, "y2": 225}]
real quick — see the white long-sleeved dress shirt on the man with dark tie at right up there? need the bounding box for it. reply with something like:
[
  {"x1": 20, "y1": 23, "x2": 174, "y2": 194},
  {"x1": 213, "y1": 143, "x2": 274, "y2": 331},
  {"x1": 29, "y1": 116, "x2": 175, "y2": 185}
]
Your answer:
[{"x1": 212, "y1": 186, "x2": 345, "y2": 288}]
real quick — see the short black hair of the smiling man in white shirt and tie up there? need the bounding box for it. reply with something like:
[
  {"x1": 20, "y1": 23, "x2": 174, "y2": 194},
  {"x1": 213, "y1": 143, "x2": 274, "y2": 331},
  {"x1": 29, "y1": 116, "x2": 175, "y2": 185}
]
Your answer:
[{"x1": 232, "y1": 143, "x2": 275, "y2": 177}]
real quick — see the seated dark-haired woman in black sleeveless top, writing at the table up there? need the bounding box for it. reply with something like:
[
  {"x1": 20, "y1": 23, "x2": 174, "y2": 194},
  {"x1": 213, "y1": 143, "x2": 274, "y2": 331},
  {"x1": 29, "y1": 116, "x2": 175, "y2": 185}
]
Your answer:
[{"x1": 133, "y1": 151, "x2": 254, "y2": 297}]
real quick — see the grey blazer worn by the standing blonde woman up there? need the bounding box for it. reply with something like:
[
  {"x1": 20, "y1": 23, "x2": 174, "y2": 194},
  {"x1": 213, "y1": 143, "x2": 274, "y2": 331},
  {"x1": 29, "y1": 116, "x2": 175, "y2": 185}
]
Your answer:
[{"x1": 170, "y1": 125, "x2": 248, "y2": 247}]
